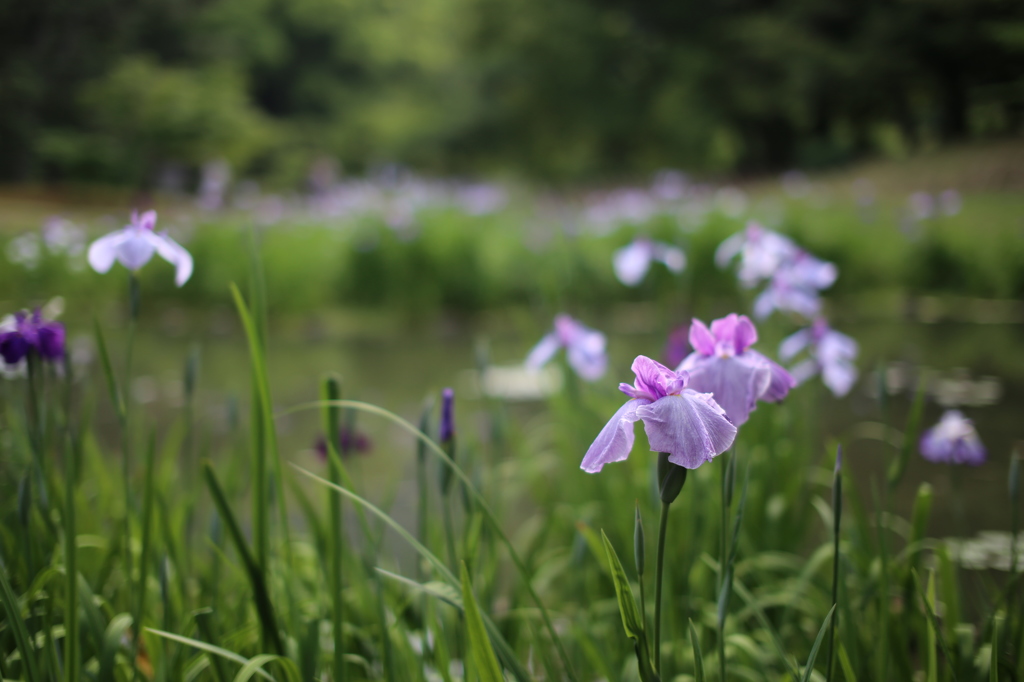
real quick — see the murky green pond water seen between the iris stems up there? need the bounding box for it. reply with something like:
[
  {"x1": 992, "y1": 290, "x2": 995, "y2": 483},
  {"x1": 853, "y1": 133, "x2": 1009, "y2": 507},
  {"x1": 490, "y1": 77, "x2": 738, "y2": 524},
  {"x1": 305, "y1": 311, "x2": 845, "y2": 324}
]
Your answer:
[{"x1": 70, "y1": 302, "x2": 1024, "y2": 561}]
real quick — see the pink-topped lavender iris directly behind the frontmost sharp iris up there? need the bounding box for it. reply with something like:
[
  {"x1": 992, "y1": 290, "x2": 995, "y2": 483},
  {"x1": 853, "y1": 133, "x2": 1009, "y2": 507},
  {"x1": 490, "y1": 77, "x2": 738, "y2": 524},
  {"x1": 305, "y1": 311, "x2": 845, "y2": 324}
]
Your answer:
[{"x1": 677, "y1": 313, "x2": 797, "y2": 426}]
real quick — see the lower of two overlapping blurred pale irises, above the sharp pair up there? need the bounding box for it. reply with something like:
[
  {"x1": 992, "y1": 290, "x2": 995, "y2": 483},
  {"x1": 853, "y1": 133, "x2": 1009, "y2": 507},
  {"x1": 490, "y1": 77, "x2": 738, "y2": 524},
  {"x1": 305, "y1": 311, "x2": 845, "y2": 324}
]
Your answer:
[{"x1": 754, "y1": 250, "x2": 839, "y2": 319}]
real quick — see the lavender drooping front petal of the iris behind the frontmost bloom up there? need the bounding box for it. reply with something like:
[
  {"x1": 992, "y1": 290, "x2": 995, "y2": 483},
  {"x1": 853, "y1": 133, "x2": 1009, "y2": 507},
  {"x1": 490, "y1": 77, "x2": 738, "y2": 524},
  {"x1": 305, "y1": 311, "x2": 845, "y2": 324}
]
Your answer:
[{"x1": 680, "y1": 353, "x2": 772, "y2": 426}]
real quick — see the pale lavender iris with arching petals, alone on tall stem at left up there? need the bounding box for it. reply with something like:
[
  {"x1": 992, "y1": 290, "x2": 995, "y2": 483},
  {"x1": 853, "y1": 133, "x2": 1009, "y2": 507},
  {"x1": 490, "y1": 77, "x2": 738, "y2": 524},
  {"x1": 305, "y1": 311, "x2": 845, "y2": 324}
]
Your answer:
[{"x1": 89, "y1": 211, "x2": 193, "y2": 287}]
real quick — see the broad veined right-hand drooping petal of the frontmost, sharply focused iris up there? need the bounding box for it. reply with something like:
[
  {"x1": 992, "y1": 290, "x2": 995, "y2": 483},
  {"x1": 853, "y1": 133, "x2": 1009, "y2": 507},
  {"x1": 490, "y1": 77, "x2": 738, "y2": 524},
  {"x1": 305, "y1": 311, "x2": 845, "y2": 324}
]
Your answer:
[{"x1": 636, "y1": 389, "x2": 736, "y2": 469}]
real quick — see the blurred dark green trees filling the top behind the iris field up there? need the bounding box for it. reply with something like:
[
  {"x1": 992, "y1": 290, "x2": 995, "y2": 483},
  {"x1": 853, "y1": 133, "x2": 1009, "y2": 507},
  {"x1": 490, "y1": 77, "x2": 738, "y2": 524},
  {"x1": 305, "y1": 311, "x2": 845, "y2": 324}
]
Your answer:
[{"x1": 0, "y1": 0, "x2": 1024, "y2": 185}]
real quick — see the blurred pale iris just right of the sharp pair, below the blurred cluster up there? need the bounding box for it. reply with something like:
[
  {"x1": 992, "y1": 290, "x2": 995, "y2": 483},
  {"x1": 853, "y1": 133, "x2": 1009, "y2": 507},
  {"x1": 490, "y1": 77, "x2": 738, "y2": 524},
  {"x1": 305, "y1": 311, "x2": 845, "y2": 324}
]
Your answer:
[{"x1": 778, "y1": 317, "x2": 858, "y2": 397}]
